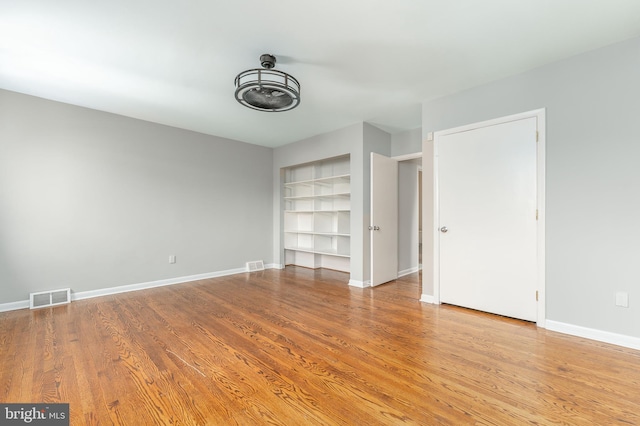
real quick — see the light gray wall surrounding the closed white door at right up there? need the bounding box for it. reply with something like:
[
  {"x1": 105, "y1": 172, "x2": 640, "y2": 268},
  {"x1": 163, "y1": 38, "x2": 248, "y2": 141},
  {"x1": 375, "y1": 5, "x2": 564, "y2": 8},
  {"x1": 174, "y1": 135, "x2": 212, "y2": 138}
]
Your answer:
[{"x1": 423, "y1": 38, "x2": 640, "y2": 337}]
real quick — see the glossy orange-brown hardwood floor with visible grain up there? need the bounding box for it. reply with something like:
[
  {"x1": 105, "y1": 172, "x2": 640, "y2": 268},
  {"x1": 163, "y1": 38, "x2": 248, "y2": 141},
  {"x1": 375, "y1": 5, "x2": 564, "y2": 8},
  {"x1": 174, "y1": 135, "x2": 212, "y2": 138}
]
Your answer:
[{"x1": 0, "y1": 267, "x2": 640, "y2": 425}]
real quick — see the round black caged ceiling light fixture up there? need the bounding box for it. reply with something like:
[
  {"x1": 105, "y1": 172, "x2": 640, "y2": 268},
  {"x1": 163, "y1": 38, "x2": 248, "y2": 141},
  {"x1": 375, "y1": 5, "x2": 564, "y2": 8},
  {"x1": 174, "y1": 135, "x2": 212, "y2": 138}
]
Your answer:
[{"x1": 235, "y1": 54, "x2": 300, "y2": 112}]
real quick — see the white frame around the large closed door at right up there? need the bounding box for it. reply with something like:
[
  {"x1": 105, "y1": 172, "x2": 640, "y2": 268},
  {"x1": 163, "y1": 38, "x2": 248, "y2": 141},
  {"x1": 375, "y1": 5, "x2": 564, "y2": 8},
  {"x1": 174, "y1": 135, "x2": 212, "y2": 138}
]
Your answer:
[{"x1": 432, "y1": 108, "x2": 546, "y2": 327}]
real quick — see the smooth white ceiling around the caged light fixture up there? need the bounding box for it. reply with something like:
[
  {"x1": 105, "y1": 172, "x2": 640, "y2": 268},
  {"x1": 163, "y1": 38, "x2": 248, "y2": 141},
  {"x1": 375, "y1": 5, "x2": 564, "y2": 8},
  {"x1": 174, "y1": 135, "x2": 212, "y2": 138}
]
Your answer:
[{"x1": 0, "y1": 0, "x2": 640, "y2": 147}]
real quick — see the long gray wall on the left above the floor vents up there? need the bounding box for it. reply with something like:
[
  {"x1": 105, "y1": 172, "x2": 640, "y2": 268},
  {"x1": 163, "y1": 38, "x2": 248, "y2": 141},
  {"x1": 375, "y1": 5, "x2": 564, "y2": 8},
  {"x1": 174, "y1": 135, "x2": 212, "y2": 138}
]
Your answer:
[{"x1": 0, "y1": 91, "x2": 273, "y2": 303}]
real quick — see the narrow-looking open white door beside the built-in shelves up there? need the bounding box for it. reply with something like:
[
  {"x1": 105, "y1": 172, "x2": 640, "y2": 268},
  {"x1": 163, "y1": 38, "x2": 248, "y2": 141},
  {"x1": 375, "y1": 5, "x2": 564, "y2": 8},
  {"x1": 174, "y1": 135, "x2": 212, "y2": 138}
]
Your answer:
[{"x1": 369, "y1": 152, "x2": 398, "y2": 286}]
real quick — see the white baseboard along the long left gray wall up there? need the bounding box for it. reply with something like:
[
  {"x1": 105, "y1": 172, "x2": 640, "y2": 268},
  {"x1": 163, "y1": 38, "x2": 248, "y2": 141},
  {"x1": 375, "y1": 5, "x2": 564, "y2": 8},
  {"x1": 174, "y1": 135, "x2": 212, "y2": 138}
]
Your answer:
[{"x1": 0, "y1": 263, "x2": 282, "y2": 312}]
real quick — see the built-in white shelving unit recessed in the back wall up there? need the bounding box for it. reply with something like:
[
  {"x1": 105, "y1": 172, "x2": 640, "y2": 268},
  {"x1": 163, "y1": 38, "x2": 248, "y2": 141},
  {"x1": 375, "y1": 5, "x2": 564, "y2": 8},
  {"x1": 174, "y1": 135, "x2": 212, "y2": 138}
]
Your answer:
[{"x1": 283, "y1": 156, "x2": 351, "y2": 272}]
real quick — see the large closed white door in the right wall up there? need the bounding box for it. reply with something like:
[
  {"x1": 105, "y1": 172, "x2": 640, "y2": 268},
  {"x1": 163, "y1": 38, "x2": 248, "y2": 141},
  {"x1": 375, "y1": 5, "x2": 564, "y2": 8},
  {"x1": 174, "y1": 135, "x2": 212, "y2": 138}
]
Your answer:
[{"x1": 435, "y1": 117, "x2": 537, "y2": 321}]
